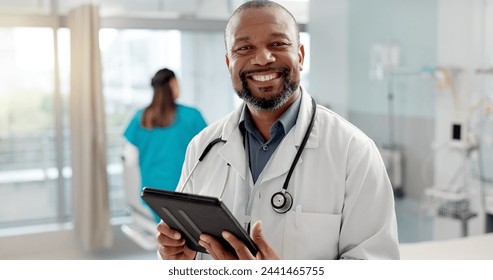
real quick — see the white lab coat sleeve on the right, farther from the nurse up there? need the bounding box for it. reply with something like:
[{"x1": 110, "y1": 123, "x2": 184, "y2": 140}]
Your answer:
[{"x1": 339, "y1": 139, "x2": 400, "y2": 259}]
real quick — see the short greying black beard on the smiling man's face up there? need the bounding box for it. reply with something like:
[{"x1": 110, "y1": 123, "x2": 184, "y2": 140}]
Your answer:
[{"x1": 235, "y1": 68, "x2": 300, "y2": 111}]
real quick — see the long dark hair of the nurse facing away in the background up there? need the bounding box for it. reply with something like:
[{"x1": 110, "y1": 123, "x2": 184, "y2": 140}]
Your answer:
[{"x1": 141, "y1": 68, "x2": 176, "y2": 129}]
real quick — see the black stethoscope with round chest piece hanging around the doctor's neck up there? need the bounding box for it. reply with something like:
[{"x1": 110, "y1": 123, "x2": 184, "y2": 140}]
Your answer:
[{"x1": 180, "y1": 98, "x2": 317, "y2": 214}]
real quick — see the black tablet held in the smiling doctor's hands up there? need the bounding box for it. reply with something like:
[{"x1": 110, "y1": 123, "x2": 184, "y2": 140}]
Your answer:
[{"x1": 141, "y1": 187, "x2": 258, "y2": 256}]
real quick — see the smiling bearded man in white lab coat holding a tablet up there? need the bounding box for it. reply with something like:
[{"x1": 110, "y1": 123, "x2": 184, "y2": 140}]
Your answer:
[{"x1": 157, "y1": 1, "x2": 399, "y2": 259}]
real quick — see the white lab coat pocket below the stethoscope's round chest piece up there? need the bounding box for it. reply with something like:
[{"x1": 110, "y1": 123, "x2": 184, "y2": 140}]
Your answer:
[{"x1": 283, "y1": 211, "x2": 341, "y2": 260}]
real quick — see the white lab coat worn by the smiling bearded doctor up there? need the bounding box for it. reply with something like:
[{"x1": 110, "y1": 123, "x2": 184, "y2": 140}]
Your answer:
[{"x1": 177, "y1": 91, "x2": 399, "y2": 259}]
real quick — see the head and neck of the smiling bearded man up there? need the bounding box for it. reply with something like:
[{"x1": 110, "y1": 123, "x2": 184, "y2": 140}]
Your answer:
[{"x1": 225, "y1": 1, "x2": 305, "y2": 140}]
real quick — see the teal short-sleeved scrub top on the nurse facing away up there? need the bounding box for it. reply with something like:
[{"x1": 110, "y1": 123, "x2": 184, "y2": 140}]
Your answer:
[{"x1": 123, "y1": 105, "x2": 207, "y2": 222}]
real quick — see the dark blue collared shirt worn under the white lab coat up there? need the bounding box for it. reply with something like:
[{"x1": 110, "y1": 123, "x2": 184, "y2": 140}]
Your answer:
[{"x1": 239, "y1": 93, "x2": 301, "y2": 183}]
